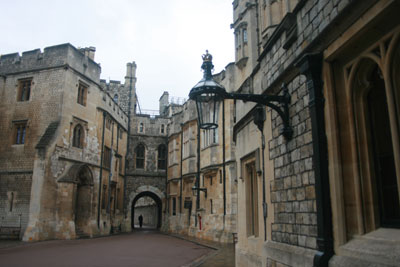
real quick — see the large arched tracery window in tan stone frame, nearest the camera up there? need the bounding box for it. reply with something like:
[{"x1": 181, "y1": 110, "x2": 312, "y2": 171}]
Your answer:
[{"x1": 324, "y1": 27, "x2": 400, "y2": 244}]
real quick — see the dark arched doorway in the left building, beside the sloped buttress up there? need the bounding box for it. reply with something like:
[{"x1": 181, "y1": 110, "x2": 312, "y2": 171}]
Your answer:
[{"x1": 74, "y1": 165, "x2": 93, "y2": 236}]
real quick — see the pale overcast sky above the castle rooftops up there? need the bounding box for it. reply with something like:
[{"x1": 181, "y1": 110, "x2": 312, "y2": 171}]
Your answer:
[{"x1": 0, "y1": 0, "x2": 234, "y2": 110}]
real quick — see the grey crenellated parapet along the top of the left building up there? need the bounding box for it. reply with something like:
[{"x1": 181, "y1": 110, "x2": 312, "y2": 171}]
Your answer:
[{"x1": 0, "y1": 43, "x2": 101, "y2": 82}]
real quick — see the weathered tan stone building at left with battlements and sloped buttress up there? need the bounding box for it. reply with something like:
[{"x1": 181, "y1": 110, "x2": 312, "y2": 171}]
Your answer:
[{"x1": 0, "y1": 44, "x2": 128, "y2": 241}]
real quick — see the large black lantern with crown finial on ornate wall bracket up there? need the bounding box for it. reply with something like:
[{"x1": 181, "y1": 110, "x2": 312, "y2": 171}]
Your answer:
[{"x1": 189, "y1": 50, "x2": 293, "y2": 139}]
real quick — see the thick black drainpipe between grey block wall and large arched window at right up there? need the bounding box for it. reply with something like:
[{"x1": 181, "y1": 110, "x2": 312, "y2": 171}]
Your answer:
[{"x1": 296, "y1": 53, "x2": 334, "y2": 267}]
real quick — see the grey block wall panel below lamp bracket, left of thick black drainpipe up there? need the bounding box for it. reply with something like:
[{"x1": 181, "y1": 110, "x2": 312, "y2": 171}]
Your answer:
[{"x1": 269, "y1": 76, "x2": 317, "y2": 249}]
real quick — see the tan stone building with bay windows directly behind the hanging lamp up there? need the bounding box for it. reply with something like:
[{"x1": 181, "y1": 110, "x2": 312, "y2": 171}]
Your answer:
[{"x1": 167, "y1": 69, "x2": 237, "y2": 243}]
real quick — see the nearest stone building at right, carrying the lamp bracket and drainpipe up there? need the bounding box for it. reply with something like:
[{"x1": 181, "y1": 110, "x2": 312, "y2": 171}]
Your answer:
[{"x1": 225, "y1": 0, "x2": 400, "y2": 266}]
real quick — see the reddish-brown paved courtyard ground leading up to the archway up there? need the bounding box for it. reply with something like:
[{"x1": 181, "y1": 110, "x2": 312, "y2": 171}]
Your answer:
[{"x1": 0, "y1": 230, "x2": 215, "y2": 267}]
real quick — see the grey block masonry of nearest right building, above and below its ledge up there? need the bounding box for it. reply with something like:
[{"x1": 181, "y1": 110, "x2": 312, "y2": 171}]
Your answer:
[{"x1": 253, "y1": 0, "x2": 356, "y2": 258}]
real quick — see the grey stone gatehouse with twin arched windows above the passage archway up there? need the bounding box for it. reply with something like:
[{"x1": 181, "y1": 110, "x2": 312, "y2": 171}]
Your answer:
[{"x1": 101, "y1": 62, "x2": 169, "y2": 232}]
